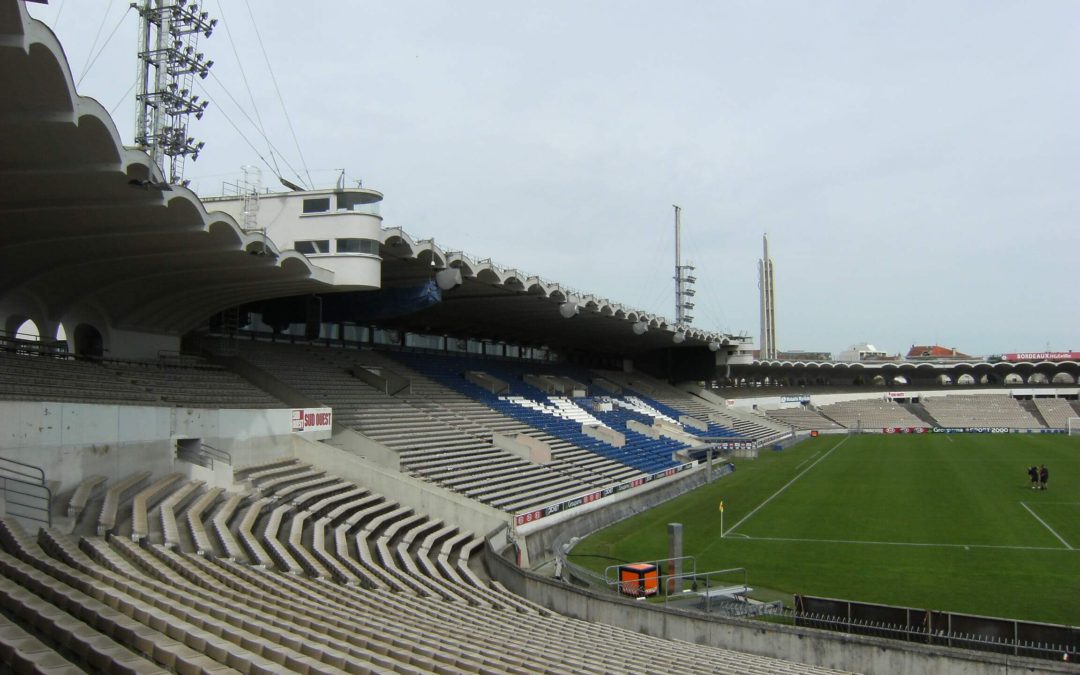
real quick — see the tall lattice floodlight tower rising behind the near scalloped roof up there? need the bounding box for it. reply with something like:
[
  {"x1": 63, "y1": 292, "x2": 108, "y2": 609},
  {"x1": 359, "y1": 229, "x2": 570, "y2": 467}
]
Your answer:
[{"x1": 133, "y1": 0, "x2": 217, "y2": 185}]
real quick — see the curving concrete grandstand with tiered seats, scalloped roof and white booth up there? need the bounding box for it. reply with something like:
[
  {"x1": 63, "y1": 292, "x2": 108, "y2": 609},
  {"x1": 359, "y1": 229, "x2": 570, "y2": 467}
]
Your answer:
[{"x1": 0, "y1": 0, "x2": 1077, "y2": 673}]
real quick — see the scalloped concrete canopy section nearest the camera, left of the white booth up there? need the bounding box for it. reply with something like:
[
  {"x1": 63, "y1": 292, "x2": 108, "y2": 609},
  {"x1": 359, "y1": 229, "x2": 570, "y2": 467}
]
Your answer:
[{"x1": 0, "y1": 0, "x2": 333, "y2": 334}]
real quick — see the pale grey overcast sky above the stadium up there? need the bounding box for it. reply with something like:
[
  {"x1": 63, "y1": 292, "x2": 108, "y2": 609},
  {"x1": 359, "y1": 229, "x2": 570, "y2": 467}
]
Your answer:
[{"x1": 28, "y1": 0, "x2": 1080, "y2": 354}]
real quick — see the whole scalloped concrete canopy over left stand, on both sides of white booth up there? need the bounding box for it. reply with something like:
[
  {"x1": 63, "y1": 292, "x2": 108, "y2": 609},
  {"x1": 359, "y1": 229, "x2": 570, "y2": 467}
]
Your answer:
[{"x1": 0, "y1": 0, "x2": 742, "y2": 355}]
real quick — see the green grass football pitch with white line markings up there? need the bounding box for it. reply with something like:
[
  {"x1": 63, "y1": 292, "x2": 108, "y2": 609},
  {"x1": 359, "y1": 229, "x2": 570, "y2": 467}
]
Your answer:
[{"x1": 570, "y1": 434, "x2": 1080, "y2": 625}]
